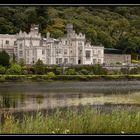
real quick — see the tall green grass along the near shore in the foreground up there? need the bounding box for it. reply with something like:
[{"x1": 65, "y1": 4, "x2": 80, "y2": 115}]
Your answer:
[{"x1": 0, "y1": 108, "x2": 140, "y2": 134}]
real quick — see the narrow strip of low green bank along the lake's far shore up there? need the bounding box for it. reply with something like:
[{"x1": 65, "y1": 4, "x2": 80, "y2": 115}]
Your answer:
[{"x1": 0, "y1": 75, "x2": 140, "y2": 82}]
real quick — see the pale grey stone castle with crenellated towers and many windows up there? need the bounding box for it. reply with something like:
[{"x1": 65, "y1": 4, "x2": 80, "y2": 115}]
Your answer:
[{"x1": 0, "y1": 24, "x2": 104, "y2": 65}]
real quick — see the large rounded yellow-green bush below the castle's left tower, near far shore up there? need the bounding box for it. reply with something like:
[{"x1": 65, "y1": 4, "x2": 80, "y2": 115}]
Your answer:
[{"x1": 6, "y1": 64, "x2": 22, "y2": 75}]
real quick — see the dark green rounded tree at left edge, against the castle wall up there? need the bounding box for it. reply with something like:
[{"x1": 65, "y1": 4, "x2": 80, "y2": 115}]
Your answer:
[{"x1": 0, "y1": 50, "x2": 10, "y2": 66}]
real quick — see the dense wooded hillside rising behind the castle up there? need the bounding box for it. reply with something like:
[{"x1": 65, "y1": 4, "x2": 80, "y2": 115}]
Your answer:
[{"x1": 0, "y1": 6, "x2": 140, "y2": 56}]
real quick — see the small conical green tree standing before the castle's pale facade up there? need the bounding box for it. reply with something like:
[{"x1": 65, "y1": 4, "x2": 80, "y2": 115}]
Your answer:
[{"x1": 35, "y1": 59, "x2": 45, "y2": 74}]
